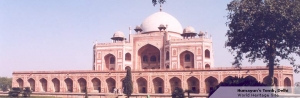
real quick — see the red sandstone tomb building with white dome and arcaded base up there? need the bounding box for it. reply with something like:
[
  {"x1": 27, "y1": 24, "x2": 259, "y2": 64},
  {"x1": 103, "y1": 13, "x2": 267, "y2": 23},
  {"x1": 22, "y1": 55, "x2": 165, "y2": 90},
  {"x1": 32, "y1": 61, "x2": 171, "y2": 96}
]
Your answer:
[{"x1": 13, "y1": 12, "x2": 294, "y2": 94}]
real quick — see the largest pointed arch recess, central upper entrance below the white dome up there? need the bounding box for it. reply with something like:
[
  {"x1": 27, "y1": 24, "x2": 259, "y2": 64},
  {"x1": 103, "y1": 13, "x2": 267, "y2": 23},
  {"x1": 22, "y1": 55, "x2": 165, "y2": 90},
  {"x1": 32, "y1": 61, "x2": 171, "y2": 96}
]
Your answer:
[{"x1": 138, "y1": 44, "x2": 160, "y2": 69}]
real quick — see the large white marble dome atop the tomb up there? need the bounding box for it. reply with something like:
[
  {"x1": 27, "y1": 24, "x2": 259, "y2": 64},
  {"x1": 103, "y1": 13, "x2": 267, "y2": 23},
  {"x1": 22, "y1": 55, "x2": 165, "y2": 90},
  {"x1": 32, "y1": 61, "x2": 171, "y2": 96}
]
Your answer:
[{"x1": 141, "y1": 12, "x2": 182, "y2": 33}]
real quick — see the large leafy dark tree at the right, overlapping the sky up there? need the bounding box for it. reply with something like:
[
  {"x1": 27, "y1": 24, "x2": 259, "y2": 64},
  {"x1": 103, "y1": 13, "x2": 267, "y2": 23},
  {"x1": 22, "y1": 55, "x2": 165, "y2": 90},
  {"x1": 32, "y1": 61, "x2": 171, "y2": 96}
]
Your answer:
[{"x1": 225, "y1": 0, "x2": 300, "y2": 86}]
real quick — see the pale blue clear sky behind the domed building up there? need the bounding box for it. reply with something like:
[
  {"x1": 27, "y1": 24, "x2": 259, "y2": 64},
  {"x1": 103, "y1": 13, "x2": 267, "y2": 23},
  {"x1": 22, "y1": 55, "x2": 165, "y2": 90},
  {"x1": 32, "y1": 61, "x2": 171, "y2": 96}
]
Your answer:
[{"x1": 0, "y1": 0, "x2": 300, "y2": 82}]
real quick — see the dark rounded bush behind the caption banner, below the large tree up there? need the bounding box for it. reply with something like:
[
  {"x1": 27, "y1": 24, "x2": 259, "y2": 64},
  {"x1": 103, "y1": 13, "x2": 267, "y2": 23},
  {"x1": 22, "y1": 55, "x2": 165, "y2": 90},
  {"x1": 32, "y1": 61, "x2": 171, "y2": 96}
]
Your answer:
[{"x1": 208, "y1": 76, "x2": 267, "y2": 97}]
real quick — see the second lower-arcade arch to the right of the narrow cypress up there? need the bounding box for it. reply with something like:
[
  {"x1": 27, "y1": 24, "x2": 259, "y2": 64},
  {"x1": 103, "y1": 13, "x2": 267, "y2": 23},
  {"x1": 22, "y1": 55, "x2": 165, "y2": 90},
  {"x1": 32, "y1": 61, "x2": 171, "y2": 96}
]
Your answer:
[{"x1": 153, "y1": 77, "x2": 165, "y2": 93}]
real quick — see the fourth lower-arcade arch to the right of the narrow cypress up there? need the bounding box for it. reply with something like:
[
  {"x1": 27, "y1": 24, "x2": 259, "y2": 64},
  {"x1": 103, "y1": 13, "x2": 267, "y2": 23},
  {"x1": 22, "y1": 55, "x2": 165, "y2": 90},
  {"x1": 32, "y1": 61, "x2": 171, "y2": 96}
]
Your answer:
[{"x1": 187, "y1": 76, "x2": 200, "y2": 93}]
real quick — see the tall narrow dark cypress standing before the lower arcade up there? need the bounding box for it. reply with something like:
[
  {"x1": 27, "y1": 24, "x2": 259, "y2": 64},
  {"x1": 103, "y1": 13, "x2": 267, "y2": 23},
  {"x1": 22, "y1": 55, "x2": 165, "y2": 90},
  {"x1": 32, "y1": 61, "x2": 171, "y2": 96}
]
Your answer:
[{"x1": 122, "y1": 67, "x2": 133, "y2": 98}]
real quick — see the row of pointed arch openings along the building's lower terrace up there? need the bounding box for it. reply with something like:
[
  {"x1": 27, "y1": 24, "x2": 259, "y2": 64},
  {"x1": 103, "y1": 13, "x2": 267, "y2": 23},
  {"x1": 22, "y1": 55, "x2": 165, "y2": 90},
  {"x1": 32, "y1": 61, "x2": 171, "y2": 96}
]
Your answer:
[{"x1": 16, "y1": 76, "x2": 291, "y2": 93}]
